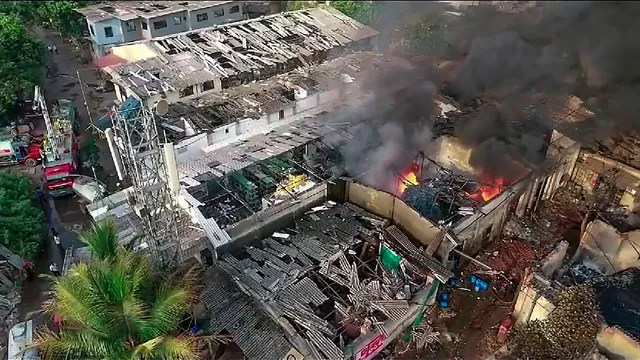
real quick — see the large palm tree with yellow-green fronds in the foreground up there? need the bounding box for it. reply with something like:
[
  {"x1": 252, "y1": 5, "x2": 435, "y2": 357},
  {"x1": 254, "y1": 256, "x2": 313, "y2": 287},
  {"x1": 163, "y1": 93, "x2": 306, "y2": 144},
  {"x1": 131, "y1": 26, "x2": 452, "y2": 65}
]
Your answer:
[{"x1": 32, "y1": 223, "x2": 211, "y2": 360}]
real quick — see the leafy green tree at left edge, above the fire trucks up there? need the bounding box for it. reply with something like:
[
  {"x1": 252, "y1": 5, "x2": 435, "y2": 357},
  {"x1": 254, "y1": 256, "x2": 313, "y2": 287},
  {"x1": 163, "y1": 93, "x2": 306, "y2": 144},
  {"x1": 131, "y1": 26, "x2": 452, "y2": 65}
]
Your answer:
[{"x1": 0, "y1": 14, "x2": 44, "y2": 116}]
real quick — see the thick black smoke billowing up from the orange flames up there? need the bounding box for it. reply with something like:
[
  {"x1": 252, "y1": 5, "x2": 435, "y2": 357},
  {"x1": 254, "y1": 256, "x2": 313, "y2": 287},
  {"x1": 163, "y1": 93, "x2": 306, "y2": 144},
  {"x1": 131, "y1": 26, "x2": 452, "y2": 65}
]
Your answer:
[{"x1": 332, "y1": 2, "x2": 640, "y2": 188}]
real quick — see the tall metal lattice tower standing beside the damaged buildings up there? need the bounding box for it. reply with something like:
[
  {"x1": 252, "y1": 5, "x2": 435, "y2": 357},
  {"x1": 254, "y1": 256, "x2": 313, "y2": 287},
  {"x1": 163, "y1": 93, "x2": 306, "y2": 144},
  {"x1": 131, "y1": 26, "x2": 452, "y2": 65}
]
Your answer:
[{"x1": 111, "y1": 97, "x2": 182, "y2": 268}]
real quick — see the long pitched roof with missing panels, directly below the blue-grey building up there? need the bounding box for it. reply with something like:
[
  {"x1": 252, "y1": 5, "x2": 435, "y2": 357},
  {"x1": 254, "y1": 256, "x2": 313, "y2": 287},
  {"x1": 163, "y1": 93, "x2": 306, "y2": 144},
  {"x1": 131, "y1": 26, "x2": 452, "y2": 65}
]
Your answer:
[{"x1": 106, "y1": 8, "x2": 377, "y2": 98}]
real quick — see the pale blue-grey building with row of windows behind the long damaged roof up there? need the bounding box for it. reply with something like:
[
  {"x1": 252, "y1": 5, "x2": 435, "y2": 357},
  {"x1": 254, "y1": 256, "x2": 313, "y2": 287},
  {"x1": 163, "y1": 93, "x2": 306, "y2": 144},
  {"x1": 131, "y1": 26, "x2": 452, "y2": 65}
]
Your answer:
[{"x1": 78, "y1": 1, "x2": 251, "y2": 57}]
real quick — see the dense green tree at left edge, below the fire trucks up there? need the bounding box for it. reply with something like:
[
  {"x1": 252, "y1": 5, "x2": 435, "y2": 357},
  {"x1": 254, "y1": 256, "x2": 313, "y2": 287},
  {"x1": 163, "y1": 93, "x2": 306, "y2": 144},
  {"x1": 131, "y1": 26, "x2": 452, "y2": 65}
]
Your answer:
[{"x1": 0, "y1": 170, "x2": 45, "y2": 260}]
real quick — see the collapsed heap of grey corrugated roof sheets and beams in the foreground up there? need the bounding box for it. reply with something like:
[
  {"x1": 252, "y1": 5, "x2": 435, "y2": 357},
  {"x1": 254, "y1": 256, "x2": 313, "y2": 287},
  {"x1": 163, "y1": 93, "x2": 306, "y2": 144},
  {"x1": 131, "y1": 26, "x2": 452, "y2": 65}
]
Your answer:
[{"x1": 202, "y1": 202, "x2": 452, "y2": 360}]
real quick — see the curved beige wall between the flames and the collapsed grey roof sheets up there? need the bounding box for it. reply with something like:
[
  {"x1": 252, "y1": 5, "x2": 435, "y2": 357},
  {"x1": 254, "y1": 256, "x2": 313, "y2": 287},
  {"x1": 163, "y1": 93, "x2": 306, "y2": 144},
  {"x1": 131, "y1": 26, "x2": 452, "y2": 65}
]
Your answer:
[{"x1": 346, "y1": 182, "x2": 440, "y2": 246}]
